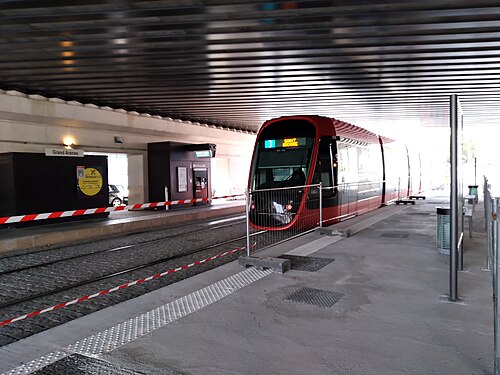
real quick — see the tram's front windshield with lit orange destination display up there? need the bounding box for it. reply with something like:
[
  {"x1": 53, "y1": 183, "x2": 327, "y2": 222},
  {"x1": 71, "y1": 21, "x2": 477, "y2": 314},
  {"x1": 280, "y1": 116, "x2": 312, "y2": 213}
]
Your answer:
[{"x1": 252, "y1": 137, "x2": 313, "y2": 189}]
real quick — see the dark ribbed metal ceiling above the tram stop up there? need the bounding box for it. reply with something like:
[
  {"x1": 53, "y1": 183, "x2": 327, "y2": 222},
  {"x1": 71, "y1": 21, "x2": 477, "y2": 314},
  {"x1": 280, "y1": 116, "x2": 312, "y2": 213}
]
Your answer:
[{"x1": 0, "y1": 0, "x2": 500, "y2": 135}]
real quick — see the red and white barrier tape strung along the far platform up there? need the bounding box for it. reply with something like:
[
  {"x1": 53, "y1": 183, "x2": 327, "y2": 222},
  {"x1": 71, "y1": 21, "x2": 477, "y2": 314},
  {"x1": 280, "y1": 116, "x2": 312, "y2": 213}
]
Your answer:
[{"x1": 0, "y1": 194, "x2": 244, "y2": 224}]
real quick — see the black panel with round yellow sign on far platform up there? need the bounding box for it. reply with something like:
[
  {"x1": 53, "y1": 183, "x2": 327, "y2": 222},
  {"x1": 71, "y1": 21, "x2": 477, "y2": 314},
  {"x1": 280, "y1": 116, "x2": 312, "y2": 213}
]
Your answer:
[{"x1": 0, "y1": 153, "x2": 109, "y2": 218}]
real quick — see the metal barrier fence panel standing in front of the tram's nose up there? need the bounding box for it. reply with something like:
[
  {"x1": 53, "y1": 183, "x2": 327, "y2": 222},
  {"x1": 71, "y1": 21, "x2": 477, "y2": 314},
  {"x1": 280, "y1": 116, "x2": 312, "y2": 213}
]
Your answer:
[{"x1": 246, "y1": 184, "x2": 323, "y2": 256}]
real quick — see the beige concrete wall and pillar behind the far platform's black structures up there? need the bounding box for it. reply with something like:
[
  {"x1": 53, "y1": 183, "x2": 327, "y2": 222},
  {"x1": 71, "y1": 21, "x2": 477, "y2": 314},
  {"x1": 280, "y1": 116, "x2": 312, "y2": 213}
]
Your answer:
[{"x1": 0, "y1": 90, "x2": 255, "y2": 203}]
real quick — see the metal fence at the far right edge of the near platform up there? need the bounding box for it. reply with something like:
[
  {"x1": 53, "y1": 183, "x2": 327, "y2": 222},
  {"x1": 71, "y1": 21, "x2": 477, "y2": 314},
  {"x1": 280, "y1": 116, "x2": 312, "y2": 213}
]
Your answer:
[{"x1": 483, "y1": 177, "x2": 500, "y2": 375}]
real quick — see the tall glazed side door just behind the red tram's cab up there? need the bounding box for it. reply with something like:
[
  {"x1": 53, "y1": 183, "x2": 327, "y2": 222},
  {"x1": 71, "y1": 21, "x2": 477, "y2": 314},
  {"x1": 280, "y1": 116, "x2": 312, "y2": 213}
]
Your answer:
[{"x1": 337, "y1": 143, "x2": 358, "y2": 220}]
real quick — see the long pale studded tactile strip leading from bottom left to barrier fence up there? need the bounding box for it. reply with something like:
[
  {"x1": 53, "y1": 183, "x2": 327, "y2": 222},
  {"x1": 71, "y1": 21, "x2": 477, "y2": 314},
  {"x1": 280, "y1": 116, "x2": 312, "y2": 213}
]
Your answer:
[{"x1": 3, "y1": 267, "x2": 272, "y2": 375}]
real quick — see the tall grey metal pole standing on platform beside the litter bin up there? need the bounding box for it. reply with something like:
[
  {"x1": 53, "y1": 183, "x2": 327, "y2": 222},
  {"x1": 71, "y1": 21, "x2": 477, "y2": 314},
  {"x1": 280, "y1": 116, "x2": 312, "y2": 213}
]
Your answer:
[{"x1": 449, "y1": 95, "x2": 458, "y2": 301}]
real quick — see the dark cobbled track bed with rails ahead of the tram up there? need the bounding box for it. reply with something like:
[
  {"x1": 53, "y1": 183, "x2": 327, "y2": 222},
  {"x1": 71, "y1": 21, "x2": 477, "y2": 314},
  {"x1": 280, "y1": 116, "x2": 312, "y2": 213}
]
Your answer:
[{"x1": 0, "y1": 216, "x2": 264, "y2": 346}]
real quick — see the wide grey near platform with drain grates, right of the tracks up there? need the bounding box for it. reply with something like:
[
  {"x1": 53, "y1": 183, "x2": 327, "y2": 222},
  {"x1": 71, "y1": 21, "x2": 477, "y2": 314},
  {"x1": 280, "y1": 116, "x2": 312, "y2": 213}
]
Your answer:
[{"x1": 0, "y1": 195, "x2": 493, "y2": 375}]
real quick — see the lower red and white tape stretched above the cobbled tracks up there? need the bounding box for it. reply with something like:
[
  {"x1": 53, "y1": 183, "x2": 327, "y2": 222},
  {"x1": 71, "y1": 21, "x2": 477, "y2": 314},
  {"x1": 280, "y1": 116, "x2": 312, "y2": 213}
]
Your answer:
[{"x1": 0, "y1": 246, "x2": 252, "y2": 327}]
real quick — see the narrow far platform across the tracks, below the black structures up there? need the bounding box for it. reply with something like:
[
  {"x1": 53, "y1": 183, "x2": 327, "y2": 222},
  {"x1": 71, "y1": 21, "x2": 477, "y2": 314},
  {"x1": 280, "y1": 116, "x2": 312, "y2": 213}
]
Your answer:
[{"x1": 0, "y1": 200, "x2": 245, "y2": 254}]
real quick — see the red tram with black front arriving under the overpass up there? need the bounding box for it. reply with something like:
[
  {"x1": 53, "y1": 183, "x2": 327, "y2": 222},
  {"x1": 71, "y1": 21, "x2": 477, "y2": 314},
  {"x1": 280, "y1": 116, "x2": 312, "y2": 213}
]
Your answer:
[{"x1": 249, "y1": 116, "x2": 421, "y2": 230}]
